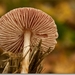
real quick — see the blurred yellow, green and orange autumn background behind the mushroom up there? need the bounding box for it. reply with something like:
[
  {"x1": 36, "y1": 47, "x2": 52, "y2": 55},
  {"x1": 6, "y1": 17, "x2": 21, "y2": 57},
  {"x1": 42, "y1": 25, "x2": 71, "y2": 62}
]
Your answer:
[{"x1": 0, "y1": 0, "x2": 75, "y2": 74}]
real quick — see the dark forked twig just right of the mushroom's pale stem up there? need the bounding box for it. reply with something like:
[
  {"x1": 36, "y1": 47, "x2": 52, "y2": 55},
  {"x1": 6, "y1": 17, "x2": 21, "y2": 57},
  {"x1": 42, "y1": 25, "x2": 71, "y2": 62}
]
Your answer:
[{"x1": 29, "y1": 41, "x2": 52, "y2": 73}]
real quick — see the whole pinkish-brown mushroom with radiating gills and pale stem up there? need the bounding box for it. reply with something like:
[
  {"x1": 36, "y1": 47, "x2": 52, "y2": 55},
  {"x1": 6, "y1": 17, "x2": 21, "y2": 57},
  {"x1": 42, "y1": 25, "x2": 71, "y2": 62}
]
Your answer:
[{"x1": 0, "y1": 7, "x2": 58, "y2": 73}]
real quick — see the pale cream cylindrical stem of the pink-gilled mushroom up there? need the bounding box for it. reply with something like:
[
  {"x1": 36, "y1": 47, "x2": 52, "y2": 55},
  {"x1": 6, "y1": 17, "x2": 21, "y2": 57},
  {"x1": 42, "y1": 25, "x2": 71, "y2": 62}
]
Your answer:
[{"x1": 21, "y1": 31, "x2": 31, "y2": 73}]
